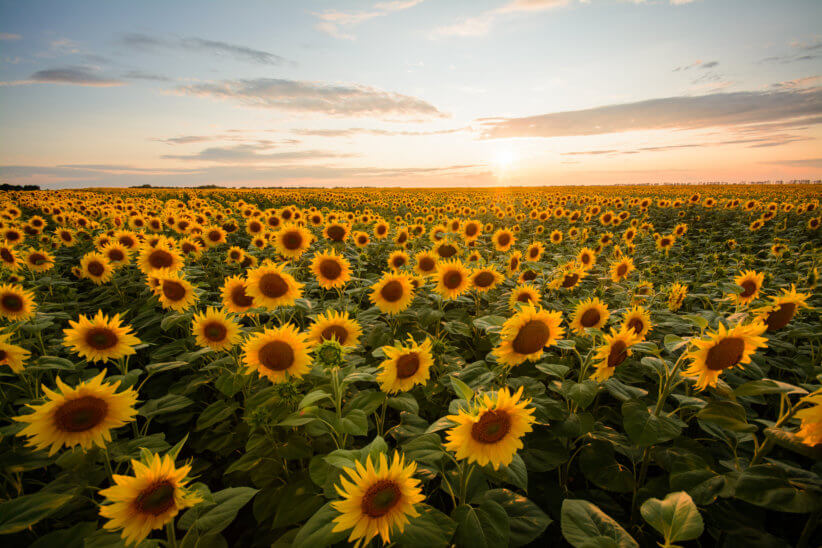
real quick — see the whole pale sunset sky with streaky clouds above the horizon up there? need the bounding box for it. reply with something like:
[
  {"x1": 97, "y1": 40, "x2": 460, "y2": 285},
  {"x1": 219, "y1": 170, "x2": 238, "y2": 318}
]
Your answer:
[{"x1": 0, "y1": 0, "x2": 822, "y2": 188}]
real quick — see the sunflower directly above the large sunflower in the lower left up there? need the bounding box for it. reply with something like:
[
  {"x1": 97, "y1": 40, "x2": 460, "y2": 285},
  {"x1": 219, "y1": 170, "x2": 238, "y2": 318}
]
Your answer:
[{"x1": 63, "y1": 310, "x2": 140, "y2": 362}]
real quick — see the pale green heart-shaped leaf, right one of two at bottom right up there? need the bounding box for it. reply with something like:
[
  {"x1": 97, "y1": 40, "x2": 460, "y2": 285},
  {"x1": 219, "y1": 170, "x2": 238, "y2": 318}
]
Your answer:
[{"x1": 639, "y1": 491, "x2": 705, "y2": 546}]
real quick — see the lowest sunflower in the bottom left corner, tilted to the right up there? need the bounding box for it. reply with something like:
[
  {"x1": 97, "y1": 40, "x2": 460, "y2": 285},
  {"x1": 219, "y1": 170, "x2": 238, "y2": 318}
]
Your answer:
[{"x1": 99, "y1": 453, "x2": 202, "y2": 545}]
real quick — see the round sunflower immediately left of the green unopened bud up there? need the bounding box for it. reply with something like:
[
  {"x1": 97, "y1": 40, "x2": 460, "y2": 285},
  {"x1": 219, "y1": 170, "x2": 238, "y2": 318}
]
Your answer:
[{"x1": 243, "y1": 324, "x2": 311, "y2": 383}]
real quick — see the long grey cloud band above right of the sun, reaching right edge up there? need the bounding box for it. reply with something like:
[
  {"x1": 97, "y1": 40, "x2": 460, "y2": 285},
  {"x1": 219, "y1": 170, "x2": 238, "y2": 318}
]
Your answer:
[{"x1": 478, "y1": 87, "x2": 822, "y2": 139}]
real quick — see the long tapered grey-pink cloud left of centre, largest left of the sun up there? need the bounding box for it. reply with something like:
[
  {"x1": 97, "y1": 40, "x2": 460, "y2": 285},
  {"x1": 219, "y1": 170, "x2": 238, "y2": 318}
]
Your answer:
[{"x1": 175, "y1": 78, "x2": 445, "y2": 118}]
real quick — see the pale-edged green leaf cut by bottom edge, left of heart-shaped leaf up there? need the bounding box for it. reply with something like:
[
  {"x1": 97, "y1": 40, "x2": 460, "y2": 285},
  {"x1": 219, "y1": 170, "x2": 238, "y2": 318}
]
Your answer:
[{"x1": 560, "y1": 499, "x2": 639, "y2": 548}]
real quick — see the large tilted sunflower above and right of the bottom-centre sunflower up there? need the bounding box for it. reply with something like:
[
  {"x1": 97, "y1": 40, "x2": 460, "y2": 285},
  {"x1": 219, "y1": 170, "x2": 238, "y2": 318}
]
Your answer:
[{"x1": 445, "y1": 386, "x2": 534, "y2": 470}]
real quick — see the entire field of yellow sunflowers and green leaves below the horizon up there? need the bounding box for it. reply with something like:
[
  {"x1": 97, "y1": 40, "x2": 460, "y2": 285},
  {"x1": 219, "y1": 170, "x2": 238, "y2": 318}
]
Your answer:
[{"x1": 0, "y1": 184, "x2": 822, "y2": 548}]
